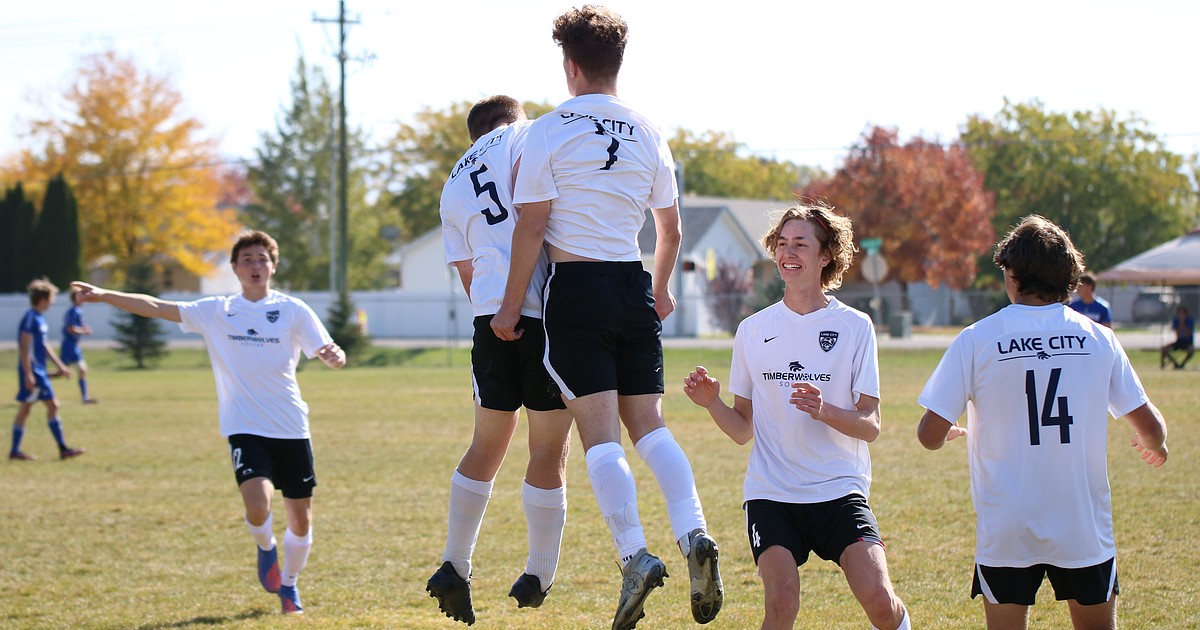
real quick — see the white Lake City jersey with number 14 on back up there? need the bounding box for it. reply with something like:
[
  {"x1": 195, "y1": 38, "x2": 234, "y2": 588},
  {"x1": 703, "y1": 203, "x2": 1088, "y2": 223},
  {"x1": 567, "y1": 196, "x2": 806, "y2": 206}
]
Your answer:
[{"x1": 917, "y1": 304, "x2": 1148, "y2": 569}]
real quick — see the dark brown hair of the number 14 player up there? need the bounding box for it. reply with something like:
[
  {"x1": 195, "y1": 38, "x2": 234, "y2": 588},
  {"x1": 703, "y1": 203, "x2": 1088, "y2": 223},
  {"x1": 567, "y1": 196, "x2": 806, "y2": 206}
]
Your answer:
[{"x1": 991, "y1": 215, "x2": 1084, "y2": 302}]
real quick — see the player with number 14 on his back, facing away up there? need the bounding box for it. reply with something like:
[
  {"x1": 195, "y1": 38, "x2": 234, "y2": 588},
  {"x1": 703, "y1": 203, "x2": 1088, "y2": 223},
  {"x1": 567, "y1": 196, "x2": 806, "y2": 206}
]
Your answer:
[{"x1": 917, "y1": 216, "x2": 1166, "y2": 629}]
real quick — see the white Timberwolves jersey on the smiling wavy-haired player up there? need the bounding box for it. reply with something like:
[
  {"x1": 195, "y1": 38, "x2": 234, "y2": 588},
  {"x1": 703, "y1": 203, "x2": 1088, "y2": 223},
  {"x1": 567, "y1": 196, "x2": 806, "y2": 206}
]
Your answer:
[{"x1": 728, "y1": 299, "x2": 880, "y2": 503}]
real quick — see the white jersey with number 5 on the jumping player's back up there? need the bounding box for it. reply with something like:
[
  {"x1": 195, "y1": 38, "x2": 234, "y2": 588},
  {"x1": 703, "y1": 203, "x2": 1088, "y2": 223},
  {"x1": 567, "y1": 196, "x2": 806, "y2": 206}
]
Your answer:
[{"x1": 442, "y1": 120, "x2": 547, "y2": 318}]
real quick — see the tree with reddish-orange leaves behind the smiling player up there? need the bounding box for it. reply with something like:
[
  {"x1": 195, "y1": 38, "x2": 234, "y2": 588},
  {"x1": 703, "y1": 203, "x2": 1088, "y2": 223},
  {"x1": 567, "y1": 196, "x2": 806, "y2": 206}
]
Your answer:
[{"x1": 802, "y1": 127, "x2": 995, "y2": 308}]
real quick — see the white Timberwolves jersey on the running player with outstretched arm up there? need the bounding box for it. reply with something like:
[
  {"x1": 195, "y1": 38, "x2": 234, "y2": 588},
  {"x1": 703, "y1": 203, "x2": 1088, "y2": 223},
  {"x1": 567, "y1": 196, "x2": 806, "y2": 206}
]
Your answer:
[{"x1": 179, "y1": 290, "x2": 332, "y2": 439}]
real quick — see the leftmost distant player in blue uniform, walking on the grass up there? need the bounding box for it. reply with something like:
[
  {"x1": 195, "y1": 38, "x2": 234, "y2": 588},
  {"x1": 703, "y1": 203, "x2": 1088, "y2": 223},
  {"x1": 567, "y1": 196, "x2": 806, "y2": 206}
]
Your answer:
[{"x1": 8, "y1": 278, "x2": 84, "y2": 461}]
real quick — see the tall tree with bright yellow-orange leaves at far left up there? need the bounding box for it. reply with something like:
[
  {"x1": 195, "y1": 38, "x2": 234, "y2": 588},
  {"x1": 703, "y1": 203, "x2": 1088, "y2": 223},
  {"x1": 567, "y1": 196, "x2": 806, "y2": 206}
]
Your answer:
[{"x1": 2, "y1": 50, "x2": 238, "y2": 280}]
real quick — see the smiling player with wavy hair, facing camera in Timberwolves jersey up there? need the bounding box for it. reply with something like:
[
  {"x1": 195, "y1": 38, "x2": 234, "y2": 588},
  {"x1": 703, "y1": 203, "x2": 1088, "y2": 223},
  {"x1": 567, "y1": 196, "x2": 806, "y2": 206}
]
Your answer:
[{"x1": 684, "y1": 204, "x2": 910, "y2": 630}]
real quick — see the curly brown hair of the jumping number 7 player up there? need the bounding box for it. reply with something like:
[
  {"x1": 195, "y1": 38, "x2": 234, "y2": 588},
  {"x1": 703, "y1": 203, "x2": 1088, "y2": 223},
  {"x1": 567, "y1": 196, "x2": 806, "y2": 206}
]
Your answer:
[{"x1": 553, "y1": 5, "x2": 629, "y2": 80}]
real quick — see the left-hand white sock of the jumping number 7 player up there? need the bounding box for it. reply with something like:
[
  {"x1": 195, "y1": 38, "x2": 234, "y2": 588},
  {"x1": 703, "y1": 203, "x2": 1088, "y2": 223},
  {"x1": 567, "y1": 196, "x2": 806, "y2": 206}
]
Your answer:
[{"x1": 584, "y1": 442, "x2": 646, "y2": 564}]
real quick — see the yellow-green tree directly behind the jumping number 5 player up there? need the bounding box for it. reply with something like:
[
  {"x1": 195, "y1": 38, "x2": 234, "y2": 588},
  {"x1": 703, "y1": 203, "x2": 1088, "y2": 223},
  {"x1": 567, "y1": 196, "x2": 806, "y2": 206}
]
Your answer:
[{"x1": 373, "y1": 101, "x2": 553, "y2": 242}]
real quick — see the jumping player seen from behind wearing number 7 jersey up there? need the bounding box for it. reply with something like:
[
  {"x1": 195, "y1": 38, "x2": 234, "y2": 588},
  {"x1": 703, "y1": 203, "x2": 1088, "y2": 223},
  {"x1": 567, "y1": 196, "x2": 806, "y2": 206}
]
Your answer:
[{"x1": 492, "y1": 5, "x2": 722, "y2": 629}]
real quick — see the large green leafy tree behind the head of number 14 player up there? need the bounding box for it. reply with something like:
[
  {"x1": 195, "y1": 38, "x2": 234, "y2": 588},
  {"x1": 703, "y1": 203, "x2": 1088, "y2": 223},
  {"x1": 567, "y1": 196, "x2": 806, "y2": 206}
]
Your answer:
[{"x1": 961, "y1": 101, "x2": 1198, "y2": 271}]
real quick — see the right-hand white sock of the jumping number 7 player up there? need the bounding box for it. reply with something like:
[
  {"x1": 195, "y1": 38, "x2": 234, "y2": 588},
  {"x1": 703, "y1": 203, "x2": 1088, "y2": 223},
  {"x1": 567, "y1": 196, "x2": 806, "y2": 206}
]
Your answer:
[{"x1": 636, "y1": 427, "x2": 708, "y2": 547}]
